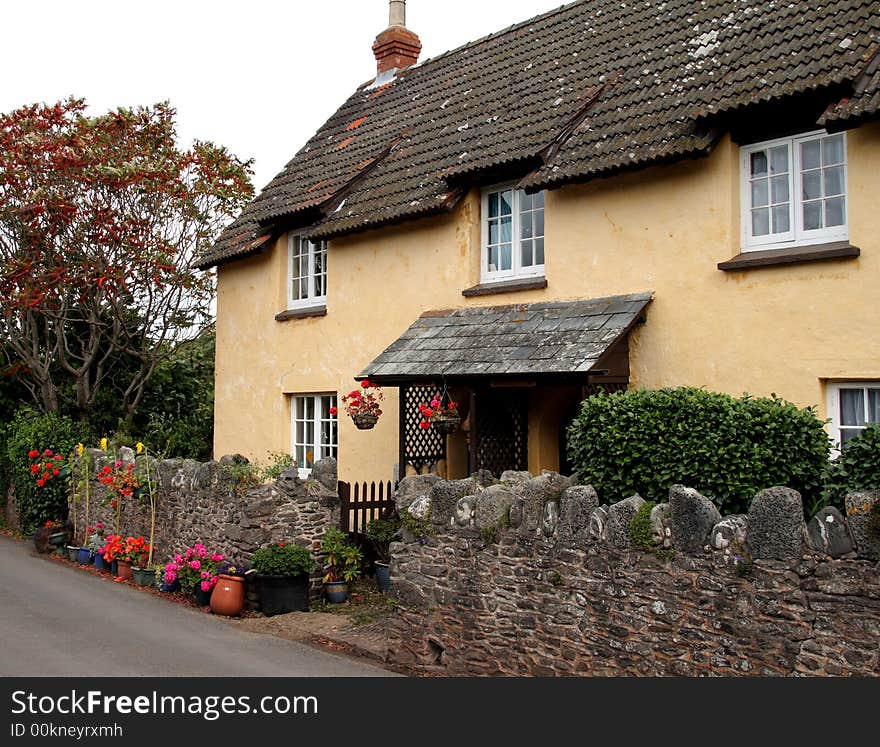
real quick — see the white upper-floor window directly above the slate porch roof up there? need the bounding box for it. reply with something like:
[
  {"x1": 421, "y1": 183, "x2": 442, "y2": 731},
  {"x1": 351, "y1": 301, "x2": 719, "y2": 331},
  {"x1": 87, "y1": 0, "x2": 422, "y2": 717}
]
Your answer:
[{"x1": 480, "y1": 185, "x2": 544, "y2": 283}]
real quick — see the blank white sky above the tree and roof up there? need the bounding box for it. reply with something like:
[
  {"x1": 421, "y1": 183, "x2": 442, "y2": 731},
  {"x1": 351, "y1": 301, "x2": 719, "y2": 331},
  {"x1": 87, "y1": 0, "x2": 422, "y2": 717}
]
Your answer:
[{"x1": 0, "y1": 0, "x2": 563, "y2": 191}]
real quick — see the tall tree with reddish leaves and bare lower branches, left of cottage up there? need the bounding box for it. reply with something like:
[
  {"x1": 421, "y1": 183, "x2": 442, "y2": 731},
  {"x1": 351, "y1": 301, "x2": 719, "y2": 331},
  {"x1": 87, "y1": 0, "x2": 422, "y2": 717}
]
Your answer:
[{"x1": 0, "y1": 99, "x2": 253, "y2": 422}]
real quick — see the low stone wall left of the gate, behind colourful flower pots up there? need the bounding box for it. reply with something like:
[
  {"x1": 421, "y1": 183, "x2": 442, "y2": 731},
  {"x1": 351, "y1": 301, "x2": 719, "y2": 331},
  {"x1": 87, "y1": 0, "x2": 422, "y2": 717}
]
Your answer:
[{"x1": 70, "y1": 449, "x2": 339, "y2": 563}]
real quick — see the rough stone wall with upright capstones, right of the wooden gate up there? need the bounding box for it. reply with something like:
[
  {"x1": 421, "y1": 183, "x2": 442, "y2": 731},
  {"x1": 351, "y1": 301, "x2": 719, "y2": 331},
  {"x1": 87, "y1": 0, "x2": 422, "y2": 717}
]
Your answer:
[{"x1": 389, "y1": 473, "x2": 880, "y2": 676}]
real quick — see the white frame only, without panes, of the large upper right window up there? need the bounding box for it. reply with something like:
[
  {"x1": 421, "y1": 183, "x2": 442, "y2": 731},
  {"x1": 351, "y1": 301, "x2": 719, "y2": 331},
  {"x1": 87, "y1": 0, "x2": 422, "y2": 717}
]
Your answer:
[{"x1": 740, "y1": 130, "x2": 850, "y2": 252}]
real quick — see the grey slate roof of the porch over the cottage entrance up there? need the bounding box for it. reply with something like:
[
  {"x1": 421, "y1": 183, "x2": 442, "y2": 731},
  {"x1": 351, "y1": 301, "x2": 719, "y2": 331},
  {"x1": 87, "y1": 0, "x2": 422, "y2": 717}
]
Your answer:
[{"x1": 356, "y1": 292, "x2": 653, "y2": 381}]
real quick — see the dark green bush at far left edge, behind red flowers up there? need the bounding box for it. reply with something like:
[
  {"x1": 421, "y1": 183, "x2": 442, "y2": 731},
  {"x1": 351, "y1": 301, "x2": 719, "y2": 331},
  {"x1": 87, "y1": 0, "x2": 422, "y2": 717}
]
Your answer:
[{"x1": 4, "y1": 407, "x2": 86, "y2": 534}]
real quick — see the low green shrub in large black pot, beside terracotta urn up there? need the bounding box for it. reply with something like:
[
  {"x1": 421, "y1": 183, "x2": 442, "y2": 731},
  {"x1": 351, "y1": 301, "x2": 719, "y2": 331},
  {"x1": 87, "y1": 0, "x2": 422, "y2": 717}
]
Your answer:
[{"x1": 251, "y1": 541, "x2": 315, "y2": 615}]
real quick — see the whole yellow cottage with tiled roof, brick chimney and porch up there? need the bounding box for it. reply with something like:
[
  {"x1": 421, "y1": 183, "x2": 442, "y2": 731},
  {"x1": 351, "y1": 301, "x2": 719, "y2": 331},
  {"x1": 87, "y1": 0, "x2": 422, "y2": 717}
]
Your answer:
[{"x1": 199, "y1": 0, "x2": 880, "y2": 480}]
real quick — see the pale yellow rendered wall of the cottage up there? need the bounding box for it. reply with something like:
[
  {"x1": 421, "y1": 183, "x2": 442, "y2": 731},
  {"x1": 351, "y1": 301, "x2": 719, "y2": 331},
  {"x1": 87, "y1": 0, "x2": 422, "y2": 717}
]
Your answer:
[{"x1": 215, "y1": 125, "x2": 880, "y2": 480}]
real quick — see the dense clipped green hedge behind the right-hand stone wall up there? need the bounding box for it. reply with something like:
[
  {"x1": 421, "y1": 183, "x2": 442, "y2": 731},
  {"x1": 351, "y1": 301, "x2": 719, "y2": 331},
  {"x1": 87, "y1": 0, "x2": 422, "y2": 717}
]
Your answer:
[{"x1": 568, "y1": 388, "x2": 829, "y2": 513}]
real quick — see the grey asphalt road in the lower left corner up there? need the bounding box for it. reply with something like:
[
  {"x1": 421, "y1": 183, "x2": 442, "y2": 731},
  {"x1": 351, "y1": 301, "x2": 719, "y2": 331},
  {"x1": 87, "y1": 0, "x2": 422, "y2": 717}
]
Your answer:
[{"x1": 0, "y1": 535, "x2": 392, "y2": 677}]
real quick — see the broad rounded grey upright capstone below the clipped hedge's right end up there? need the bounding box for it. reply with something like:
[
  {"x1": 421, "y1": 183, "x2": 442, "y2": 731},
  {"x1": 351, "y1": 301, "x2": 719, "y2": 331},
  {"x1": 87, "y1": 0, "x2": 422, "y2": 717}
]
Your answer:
[{"x1": 748, "y1": 487, "x2": 805, "y2": 560}]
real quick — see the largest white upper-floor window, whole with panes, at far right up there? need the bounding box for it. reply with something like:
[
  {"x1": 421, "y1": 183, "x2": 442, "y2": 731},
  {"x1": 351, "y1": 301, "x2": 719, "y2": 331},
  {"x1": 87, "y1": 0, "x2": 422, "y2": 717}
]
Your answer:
[{"x1": 740, "y1": 132, "x2": 849, "y2": 251}]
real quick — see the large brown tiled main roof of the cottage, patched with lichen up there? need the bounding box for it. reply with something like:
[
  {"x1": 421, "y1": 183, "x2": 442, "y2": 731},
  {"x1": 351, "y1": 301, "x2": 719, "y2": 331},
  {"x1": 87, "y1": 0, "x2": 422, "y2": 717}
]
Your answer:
[{"x1": 200, "y1": 0, "x2": 880, "y2": 266}]
